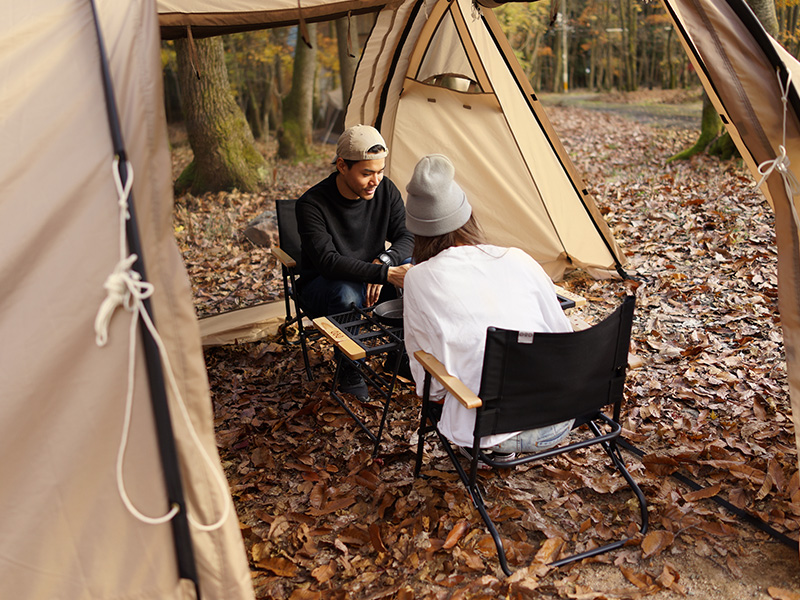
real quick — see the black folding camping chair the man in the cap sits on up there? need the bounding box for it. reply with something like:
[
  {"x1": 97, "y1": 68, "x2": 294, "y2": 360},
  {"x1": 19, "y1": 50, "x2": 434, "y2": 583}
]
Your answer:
[{"x1": 272, "y1": 200, "x2": 319, "y2": 381}]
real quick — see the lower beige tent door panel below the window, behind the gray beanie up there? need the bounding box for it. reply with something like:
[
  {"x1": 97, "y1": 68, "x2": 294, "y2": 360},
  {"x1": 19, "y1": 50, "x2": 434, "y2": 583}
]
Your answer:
[{"x1": 389, "y1": 80, "x2": 569, "y2": 279}]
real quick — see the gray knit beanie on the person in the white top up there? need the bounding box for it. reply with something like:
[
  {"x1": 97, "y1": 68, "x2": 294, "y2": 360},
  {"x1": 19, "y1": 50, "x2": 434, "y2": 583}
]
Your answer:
[{"x1": 406, "y1": 154, "x2": 472, "y2": 237}]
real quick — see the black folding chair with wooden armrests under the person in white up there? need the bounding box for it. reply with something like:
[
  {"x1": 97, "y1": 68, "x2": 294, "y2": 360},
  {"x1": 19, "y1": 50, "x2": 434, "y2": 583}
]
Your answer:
[{"x1": 414, "y1": 296, "x2": 647, "y2": 575}]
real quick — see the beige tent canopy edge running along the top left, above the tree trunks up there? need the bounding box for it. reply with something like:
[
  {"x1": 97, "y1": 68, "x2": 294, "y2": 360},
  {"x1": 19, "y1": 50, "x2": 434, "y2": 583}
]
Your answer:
[{"x1": 158, "y1": 0, "x2": 387, "y2": 39}]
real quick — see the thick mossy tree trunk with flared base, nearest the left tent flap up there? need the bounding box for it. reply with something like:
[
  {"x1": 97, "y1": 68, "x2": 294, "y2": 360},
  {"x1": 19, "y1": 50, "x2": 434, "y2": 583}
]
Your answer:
[{"x1": 175, "y1": 37, "x2": 266, "y2": 194}]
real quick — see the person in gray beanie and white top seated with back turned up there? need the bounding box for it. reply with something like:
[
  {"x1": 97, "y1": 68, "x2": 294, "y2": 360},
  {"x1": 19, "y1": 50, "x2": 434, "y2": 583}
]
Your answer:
[{"x1": 403, "y1": 154, "x2": 572, "y2": 460}]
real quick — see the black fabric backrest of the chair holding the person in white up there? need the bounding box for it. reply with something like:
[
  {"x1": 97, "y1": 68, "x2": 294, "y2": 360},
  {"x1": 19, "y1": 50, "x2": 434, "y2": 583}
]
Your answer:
[{"x1": 475, "y1": 296, "x2": 635, "y2": 436}]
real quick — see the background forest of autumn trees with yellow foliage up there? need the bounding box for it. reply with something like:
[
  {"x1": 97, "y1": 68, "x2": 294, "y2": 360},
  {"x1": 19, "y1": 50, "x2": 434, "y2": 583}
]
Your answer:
[{"x1": 162, "y1": 0, "x2": 800, "y2": 158}]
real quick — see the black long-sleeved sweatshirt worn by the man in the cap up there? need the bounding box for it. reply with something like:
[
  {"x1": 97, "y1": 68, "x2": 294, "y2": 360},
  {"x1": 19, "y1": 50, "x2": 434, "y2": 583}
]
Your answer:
[{"x1": 295, "y1": 172, "x2": 414, "y2": 287}]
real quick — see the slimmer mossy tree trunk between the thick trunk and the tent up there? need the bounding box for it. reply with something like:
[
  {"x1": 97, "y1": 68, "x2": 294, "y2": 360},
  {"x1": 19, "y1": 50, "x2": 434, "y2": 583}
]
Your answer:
[{"x1": 278, "y1": 23, "x2": 317, "y2": 160}]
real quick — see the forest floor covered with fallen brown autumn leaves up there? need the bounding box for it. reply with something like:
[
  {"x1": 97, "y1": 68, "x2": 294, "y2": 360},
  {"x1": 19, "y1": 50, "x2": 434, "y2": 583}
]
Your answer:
[{"x1": 172, "y1": 86, "x2": 800, "y2": 600}]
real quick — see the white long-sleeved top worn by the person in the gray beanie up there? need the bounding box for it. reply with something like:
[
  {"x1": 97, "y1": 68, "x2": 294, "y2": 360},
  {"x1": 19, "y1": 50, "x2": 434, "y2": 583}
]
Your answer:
[{"x1": 403, "y1": 245, "x2": 572, "y2": 448}]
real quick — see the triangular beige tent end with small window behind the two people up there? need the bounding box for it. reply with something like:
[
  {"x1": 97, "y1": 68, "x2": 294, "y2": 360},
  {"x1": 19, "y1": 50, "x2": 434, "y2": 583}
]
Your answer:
[{"x1": 346, "y1": 0, "x2": 625, "y2": 281}]
